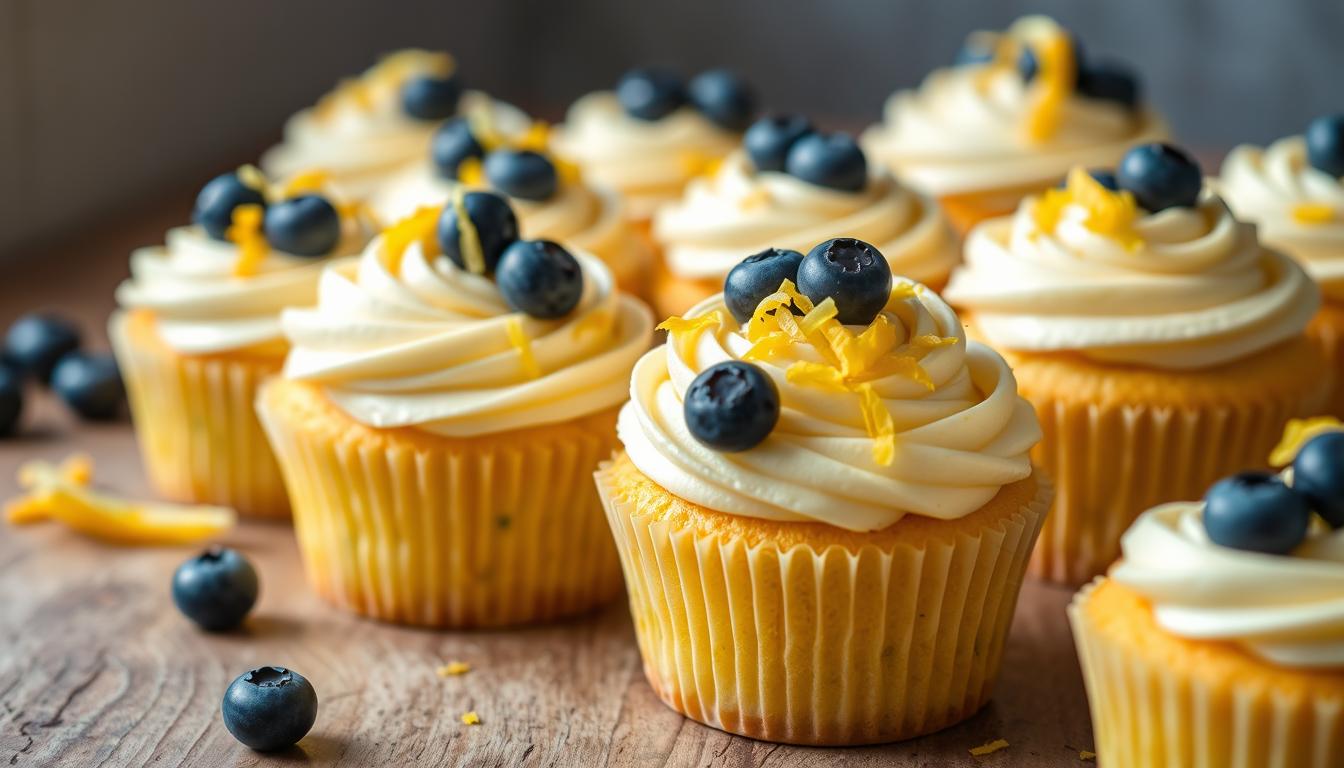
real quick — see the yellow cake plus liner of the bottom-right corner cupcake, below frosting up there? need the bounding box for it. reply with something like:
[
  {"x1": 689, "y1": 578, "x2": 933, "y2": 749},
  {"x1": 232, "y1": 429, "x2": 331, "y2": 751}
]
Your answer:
[{"x1": 1068, "y1": 578, "x2": 1344, "y2": 768}]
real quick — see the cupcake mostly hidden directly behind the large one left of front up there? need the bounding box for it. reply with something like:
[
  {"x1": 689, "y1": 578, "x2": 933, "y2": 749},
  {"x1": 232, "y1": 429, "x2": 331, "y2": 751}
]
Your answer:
[{"x1": 370, "y1": 117, "x2": 652, "y2": 296}]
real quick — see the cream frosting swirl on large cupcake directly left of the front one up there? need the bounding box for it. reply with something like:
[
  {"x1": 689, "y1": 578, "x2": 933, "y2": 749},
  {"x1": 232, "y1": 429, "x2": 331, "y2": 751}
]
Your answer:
[{"x1": 276, "y1": 238, "x2": 653, "y2": 437}]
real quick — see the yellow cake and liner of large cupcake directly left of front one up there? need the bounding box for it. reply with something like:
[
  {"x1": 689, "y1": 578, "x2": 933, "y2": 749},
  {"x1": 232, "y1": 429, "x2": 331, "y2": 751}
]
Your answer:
[{"x1": 258, "y1": 379, "x2": 621, "y2": 628}]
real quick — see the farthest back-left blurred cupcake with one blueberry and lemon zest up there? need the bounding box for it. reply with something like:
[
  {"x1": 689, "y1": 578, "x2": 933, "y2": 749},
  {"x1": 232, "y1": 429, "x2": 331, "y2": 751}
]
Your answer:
[{"x1": 261, "y1": 50, "x2": 528, "y2": 202}]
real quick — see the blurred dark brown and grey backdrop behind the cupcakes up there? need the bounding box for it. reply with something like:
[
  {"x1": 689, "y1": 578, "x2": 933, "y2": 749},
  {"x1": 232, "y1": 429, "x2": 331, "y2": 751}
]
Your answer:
[{"x1": 0, "y1": 0, "x2": 1344, "y2": 260}]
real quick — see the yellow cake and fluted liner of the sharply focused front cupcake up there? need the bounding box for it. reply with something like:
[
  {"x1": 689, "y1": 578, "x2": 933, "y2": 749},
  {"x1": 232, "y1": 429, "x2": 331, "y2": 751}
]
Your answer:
[{"x1": 597, "y1": 456, "x2": 1050, "y2": 745}]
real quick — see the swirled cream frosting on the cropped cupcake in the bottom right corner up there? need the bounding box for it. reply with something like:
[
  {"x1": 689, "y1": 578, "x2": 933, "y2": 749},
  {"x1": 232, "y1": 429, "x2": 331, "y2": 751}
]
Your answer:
[{"x1": 1110, "y1": 502, "x2": 1344, "y2": 668}]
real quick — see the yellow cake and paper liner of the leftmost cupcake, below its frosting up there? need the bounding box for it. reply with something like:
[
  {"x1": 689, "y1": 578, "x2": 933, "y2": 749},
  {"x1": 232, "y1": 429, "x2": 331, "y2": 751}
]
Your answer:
[{"x1": 109, "y1": 312, "x2": 289, "y2": 519}]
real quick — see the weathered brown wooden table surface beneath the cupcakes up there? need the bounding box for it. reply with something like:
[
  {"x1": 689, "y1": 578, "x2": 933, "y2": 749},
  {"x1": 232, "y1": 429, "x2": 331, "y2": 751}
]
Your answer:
[{"x1": 0, "y1": 198, "x2": 1093, "y2": 768}]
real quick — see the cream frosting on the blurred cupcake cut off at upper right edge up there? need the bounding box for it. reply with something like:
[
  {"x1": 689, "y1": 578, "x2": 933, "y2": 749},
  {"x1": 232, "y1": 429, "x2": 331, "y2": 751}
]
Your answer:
[{"x1": 1216, "y1": 136, "x2": 1344, "y2": 301}]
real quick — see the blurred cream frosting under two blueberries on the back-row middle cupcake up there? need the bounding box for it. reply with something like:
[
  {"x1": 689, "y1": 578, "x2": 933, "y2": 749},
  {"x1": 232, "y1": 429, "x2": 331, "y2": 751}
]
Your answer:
[{"x1": 551, "y1": 91, "x2": 741, "y2": 218}]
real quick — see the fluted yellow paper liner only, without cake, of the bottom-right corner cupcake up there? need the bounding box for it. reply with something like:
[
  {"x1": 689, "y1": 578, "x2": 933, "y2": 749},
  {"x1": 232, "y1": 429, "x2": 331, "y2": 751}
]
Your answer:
[{"x1": 1068, "y1": 580, "x2": 1344, "y2": 768}]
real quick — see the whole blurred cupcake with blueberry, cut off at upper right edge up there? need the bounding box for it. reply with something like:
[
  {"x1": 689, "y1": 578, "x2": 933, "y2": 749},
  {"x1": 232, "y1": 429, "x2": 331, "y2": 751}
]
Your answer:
[{"x1": 1218, "y1": 114, "x2": 1344, "y2": 416}]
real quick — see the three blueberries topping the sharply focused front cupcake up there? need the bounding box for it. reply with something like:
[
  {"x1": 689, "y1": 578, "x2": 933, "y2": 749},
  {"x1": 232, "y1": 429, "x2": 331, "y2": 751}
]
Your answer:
[{"x1": 681, "y1": 237, "x2": 892, "y2": 452}]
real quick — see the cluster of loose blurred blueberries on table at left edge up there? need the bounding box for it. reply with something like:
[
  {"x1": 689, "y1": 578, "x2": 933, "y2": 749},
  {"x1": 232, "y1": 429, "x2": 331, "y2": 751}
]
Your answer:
[{"x1": 0, "y1": 312, "x2": 126, "y2": 436}]
